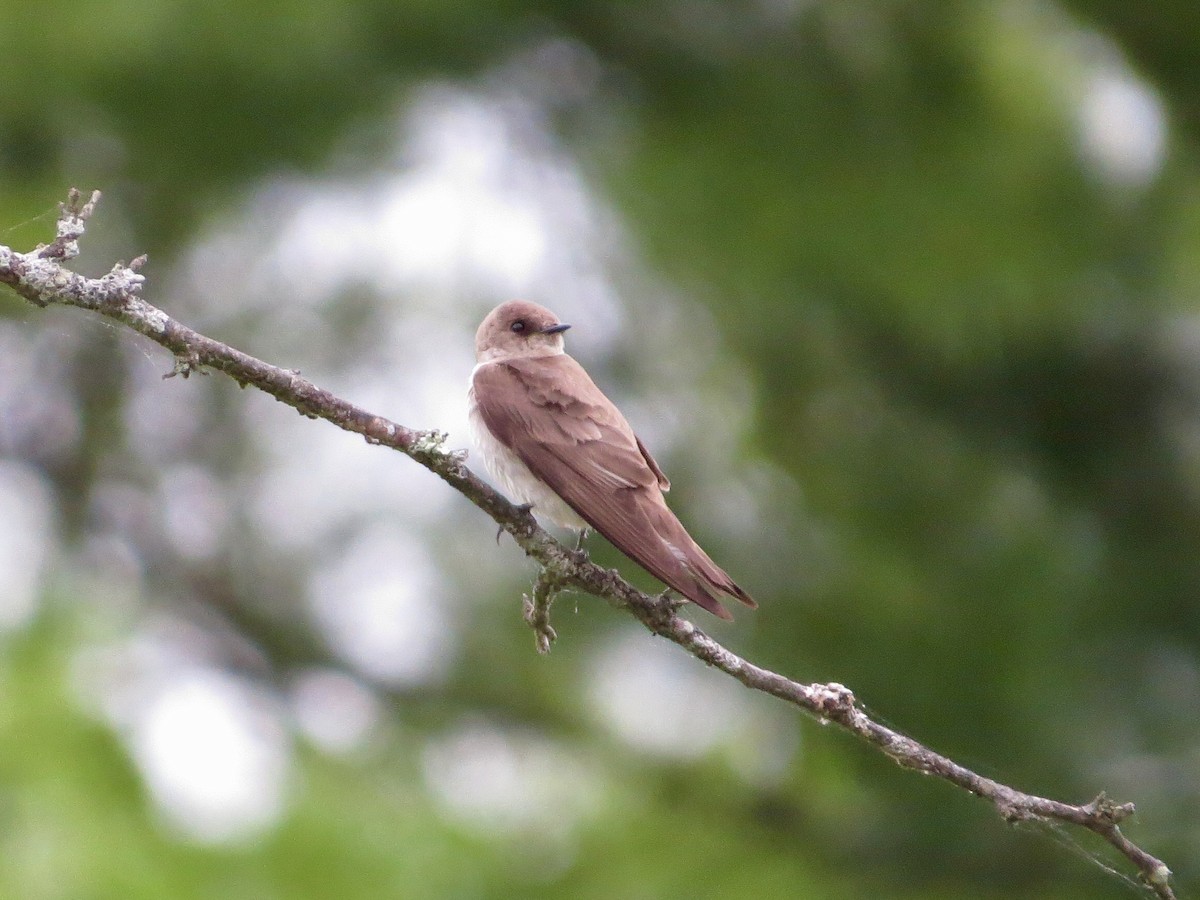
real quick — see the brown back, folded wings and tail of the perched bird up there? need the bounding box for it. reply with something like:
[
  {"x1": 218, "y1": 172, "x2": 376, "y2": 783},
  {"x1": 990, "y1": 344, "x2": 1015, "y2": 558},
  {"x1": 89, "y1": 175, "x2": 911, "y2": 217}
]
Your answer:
[{"x1": 475, "y1": 355, "x2": 755, "y2": 618}]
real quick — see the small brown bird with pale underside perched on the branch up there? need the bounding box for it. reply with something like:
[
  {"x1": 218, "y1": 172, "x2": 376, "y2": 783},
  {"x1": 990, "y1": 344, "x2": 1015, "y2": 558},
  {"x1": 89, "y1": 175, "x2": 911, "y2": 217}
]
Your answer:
[{"x1": 468, "y1": 300, "x2": 757, "y2": 619}]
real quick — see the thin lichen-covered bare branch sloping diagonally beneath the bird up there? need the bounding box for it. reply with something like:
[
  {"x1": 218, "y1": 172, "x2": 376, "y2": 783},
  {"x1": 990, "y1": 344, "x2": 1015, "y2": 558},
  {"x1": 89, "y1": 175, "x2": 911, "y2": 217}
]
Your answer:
[{"x1": 0, "y1": 190, "x2": 1175, "y2": 900}]
